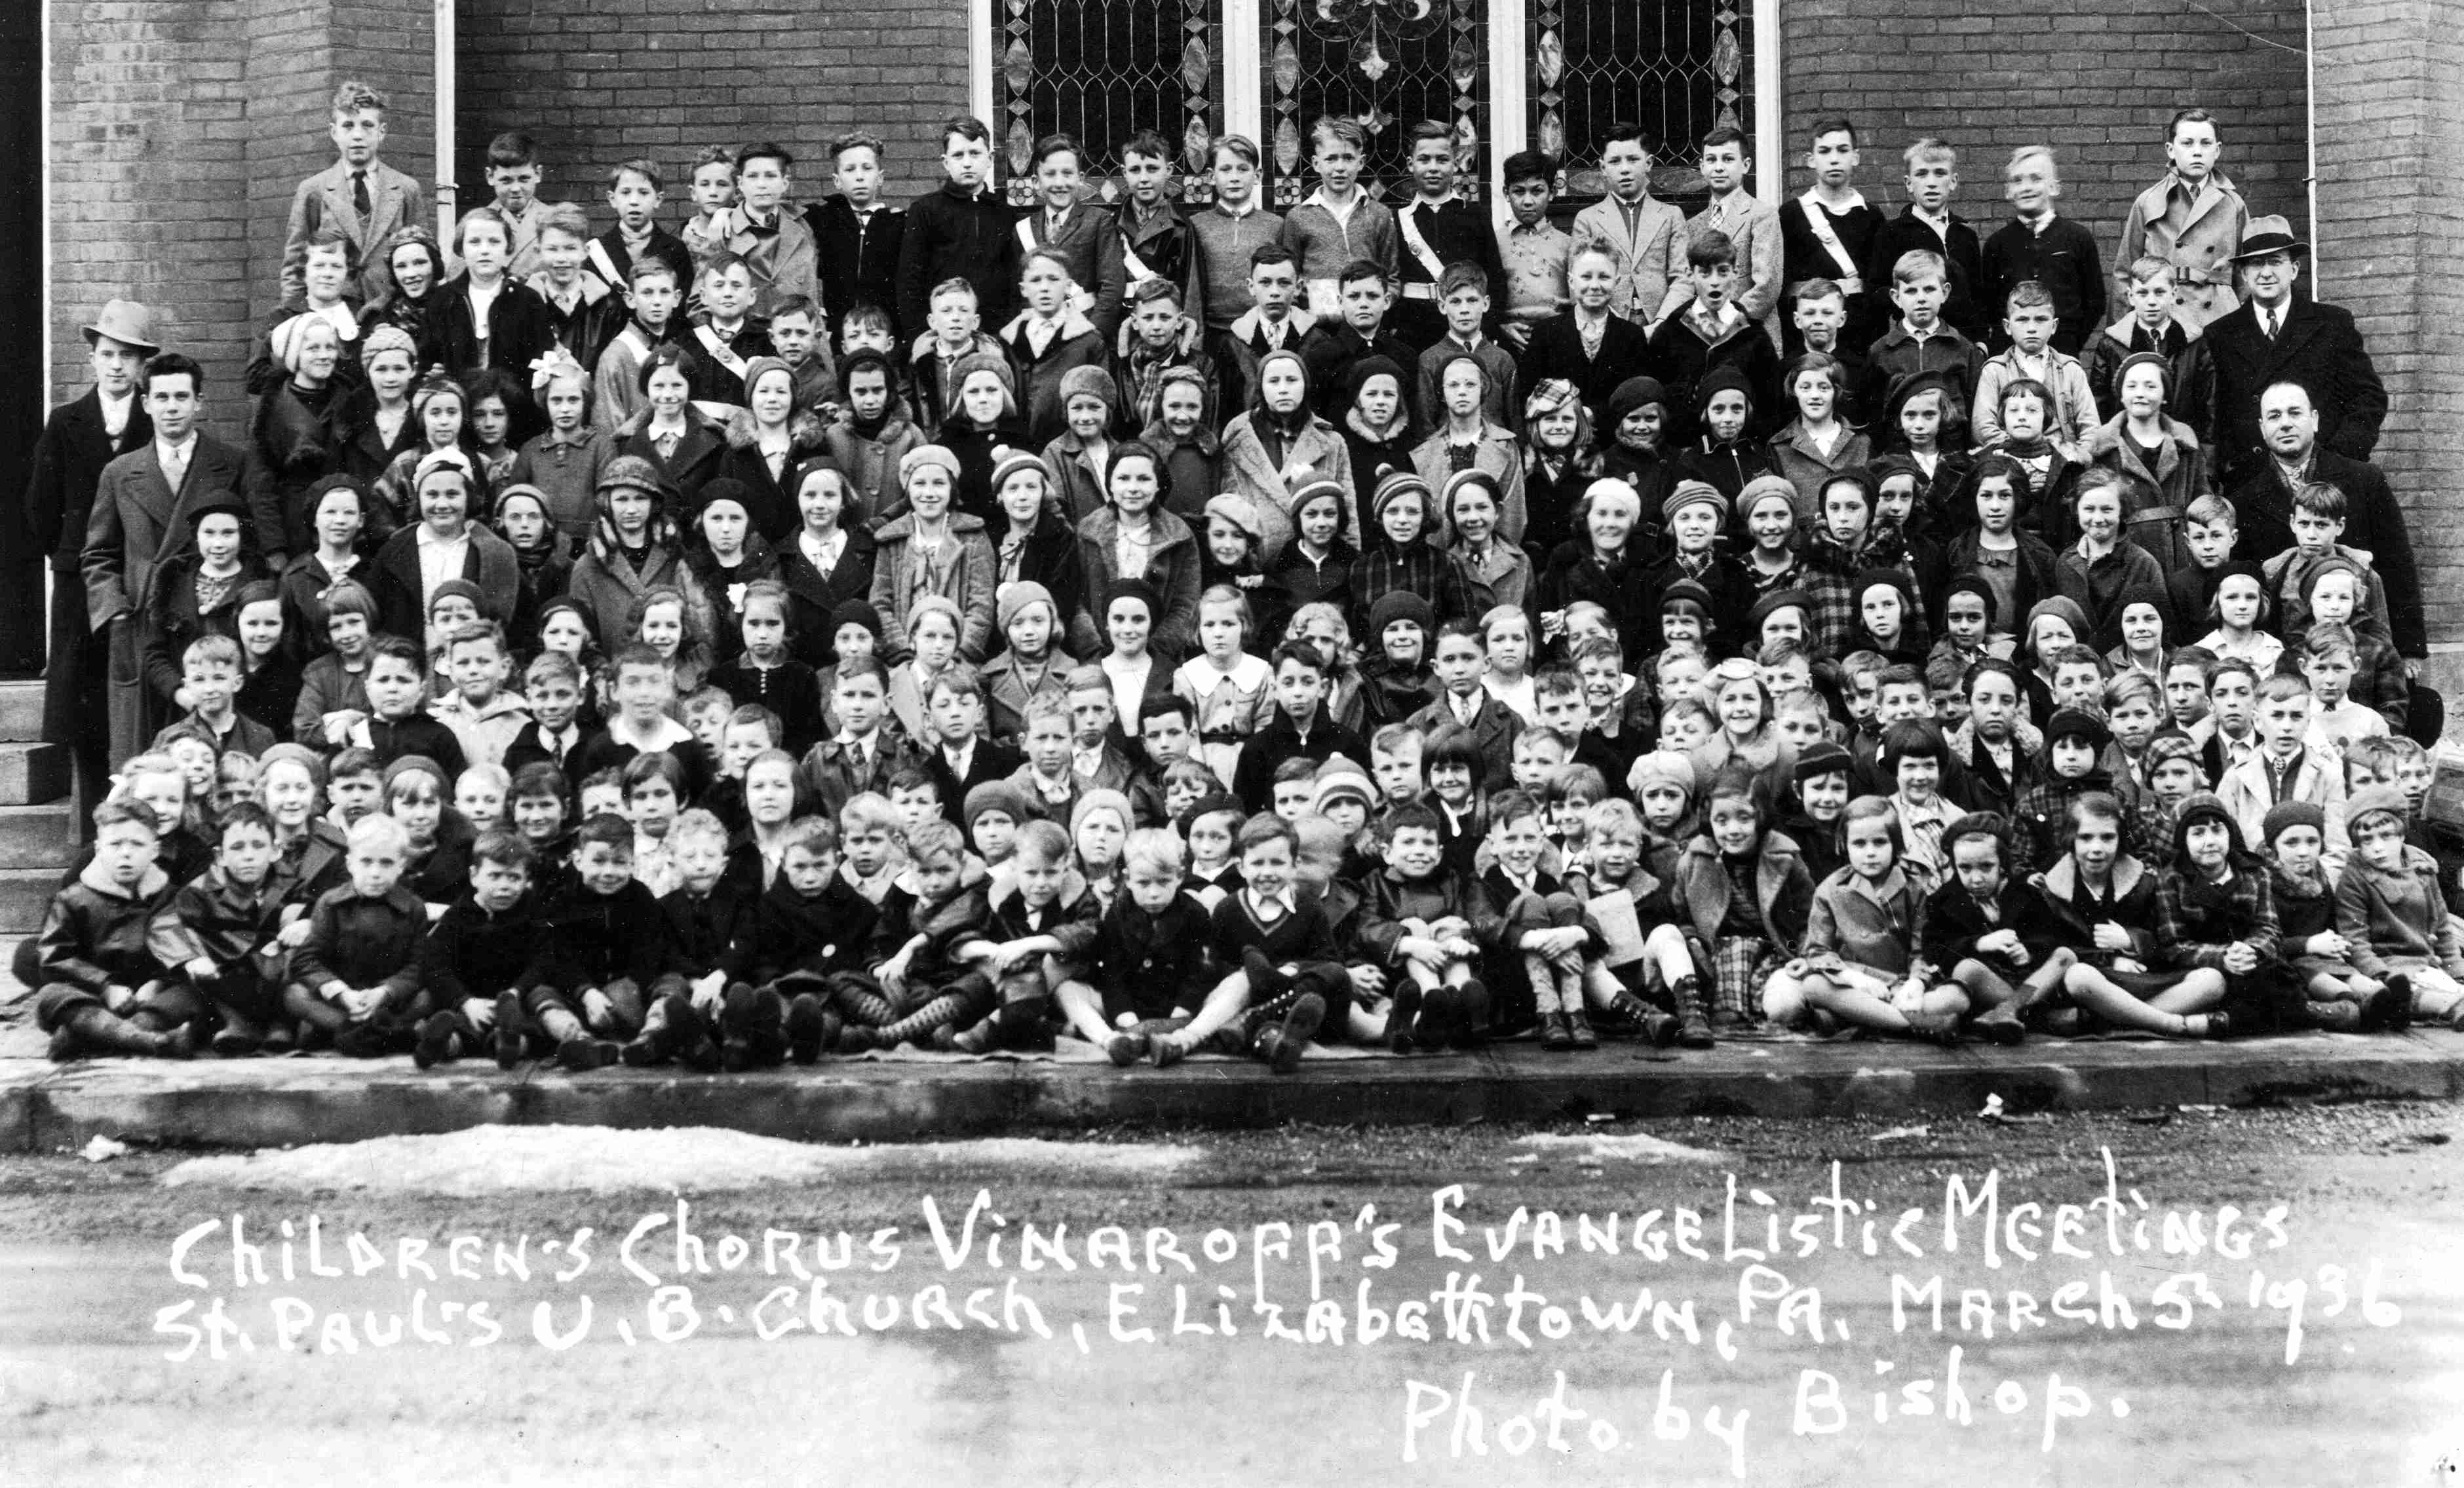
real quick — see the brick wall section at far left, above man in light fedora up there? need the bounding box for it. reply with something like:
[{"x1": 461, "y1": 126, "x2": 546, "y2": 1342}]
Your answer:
[{"x1": 47, "y1": 0, "x2": 434, "y2": 436}]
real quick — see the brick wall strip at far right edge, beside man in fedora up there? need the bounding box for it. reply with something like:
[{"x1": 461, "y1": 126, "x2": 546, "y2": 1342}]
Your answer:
[{"x1": 2316, "y1": 0, "x2": 2464, "y2": 679}]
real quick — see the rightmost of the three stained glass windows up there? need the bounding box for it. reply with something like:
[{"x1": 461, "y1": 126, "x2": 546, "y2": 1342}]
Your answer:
[{"x1": 1528, "y1": 0, "x2": 1779, "y2": 200}]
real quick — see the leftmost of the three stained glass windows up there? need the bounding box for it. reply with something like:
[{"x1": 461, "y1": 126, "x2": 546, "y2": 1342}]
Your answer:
[{"x1": 993, "y1": 0, "x2": 1222, "y2": 207}]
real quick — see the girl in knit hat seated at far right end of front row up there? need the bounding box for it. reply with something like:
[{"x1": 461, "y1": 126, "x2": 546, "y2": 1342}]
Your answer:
[{"x1": 2336, "y1": 786, "x2": 2464, "y2": 1027}]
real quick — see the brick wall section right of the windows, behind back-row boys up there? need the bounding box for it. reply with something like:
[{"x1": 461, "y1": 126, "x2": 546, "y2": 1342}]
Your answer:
[{"x1": 1779, "y1": 0, "x2": 2324, "y2": 259}]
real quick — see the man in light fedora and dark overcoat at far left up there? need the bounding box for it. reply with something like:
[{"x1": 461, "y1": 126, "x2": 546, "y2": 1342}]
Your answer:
[{"x1": 25, "y1": 301, "x2": 160, "y2": 820}]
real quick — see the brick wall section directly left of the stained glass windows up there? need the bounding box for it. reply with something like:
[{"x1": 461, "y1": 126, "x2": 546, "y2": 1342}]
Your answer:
[{"x1": 456, "y1": 0, "x2": 966, "y2": 229}]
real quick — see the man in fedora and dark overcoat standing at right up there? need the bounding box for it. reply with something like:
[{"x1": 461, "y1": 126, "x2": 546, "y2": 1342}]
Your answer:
[{"x1": 2183, "y1": 217, "x2": 2395, "y2": 480}]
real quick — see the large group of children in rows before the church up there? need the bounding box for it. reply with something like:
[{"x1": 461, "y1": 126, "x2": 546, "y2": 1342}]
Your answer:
[{"x1": 27, "y1": 91, "x2": 2464, "y2": 1072}]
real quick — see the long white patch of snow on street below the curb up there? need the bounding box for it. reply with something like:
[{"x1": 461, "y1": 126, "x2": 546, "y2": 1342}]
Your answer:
[{"x1": 163, "y1": 1126, "x2": 1207, "y2": 1195}]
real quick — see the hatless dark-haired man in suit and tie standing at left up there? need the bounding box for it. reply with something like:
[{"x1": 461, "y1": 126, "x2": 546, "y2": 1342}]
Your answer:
[{"x1": 79, "y1": 353, "x2": 283, "y2": 766}]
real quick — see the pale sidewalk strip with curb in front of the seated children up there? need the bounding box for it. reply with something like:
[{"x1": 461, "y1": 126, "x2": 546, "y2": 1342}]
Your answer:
[{"x1": 0, "y1": 1030, "x2": 2464, "y2": 1153}]
